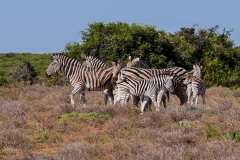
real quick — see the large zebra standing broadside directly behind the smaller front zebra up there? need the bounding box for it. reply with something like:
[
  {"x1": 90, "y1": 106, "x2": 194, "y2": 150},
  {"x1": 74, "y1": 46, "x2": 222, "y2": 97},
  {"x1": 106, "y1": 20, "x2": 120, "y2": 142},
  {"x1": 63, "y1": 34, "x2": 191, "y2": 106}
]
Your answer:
[{"x1": 113, "y1": 67, "x2": 187, "y2": 105}]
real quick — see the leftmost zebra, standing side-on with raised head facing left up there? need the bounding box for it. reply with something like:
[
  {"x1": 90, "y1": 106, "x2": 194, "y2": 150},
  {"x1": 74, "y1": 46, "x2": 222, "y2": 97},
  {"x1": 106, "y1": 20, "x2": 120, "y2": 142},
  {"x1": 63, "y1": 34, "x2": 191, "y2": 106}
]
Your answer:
[{"x1": 46, "y1": 54, "x2": 121, "y2": 106}]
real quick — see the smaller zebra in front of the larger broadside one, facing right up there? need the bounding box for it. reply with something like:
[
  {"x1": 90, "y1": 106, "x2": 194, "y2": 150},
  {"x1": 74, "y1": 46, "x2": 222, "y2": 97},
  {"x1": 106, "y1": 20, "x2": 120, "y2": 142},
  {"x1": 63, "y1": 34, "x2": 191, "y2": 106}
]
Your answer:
[{"x1": 117, "y1": 74, "x2": 176, "y2": 113}]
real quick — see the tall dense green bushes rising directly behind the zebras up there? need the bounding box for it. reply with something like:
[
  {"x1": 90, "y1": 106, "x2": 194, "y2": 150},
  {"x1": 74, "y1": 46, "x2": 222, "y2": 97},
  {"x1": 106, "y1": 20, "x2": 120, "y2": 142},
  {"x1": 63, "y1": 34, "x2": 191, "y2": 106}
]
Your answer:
[{"x1": 66, "y1": 22, "x2": 240, "y2": 86}]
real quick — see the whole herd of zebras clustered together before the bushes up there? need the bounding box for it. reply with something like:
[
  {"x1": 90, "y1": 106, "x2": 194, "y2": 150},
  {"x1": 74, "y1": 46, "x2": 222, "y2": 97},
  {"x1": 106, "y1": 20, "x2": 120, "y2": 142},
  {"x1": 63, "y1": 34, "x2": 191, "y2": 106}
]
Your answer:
[{"x1": 46, "y1": 54, "x2": 206, "y2": 113}]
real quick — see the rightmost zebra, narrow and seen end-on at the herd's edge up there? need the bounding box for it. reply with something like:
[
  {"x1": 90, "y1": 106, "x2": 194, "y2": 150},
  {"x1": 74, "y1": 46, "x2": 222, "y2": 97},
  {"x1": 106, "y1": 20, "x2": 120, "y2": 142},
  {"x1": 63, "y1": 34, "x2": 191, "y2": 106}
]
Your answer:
[{"x1": 183, "y1": 64, "x2": 206, "y2": 105}]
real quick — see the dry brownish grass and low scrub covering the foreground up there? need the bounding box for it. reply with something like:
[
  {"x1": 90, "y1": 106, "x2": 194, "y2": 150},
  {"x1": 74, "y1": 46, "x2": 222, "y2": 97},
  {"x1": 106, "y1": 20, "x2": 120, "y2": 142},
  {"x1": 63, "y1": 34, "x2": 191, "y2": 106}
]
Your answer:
[{"x1": 0, "y1": 85, "x2": 240, "y2": 160}]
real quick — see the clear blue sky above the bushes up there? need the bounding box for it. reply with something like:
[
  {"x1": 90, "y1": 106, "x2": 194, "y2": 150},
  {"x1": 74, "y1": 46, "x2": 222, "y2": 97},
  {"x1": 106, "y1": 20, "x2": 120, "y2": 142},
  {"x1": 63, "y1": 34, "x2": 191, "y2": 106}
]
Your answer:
[{"x1": 0, "y1": 0, "x2": 240, "y2": 52}]
